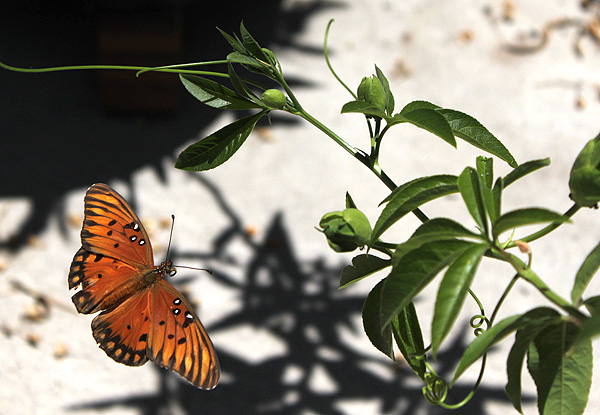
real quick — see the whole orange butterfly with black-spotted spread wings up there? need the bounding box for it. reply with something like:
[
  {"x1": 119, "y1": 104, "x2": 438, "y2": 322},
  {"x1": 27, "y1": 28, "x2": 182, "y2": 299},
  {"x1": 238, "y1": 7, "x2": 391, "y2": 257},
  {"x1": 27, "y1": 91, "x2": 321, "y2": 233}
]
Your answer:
[{"x1": 69, "y1": 184, "x2": 220, "y2": 389}]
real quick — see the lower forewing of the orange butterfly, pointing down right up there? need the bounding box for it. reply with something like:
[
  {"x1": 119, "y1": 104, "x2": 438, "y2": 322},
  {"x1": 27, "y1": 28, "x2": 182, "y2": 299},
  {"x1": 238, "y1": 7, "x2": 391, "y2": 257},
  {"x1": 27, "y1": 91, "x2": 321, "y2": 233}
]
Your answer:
[{"x1": 148, "y1": 279, "x2": 219, "y2": 389}]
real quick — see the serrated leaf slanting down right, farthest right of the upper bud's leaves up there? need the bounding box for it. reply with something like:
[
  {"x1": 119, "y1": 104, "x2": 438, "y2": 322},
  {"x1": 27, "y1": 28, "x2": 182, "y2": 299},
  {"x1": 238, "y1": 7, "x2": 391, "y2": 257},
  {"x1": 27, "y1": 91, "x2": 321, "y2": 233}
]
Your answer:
[{"x1": 438, "y1": 108, "x2": 518, "y2": 167}]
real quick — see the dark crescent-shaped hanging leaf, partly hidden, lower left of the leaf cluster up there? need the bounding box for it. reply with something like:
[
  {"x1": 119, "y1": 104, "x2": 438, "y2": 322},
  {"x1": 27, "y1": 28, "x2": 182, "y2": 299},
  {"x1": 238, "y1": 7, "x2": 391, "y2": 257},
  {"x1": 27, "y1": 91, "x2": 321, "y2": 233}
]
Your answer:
[{"x1": 362, "y1": 279, "x2": 394, "y2": 359}]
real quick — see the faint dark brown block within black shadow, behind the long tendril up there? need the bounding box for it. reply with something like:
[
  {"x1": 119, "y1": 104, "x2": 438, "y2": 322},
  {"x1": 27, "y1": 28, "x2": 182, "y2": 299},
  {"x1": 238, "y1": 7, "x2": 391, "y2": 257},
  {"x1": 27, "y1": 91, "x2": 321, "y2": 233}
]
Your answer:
[{"x1": 97, "y1": 7, "x2": 182, "y2": 113}]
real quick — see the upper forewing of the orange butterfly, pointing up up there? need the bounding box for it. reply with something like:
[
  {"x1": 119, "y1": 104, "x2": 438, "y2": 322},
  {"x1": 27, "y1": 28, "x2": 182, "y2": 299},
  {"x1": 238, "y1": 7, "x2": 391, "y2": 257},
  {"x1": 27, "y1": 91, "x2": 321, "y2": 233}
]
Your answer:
[{"x1": 81, "y1": 183, "x2": 154, "y2": 269}]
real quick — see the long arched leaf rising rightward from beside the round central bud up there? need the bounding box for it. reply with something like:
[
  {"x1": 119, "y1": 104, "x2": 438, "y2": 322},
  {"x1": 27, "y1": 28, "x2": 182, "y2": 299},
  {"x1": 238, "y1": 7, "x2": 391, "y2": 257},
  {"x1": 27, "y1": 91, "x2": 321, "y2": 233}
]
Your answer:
[{"x1": 369, "y1": 175, "x2": 458, "y2": 245}]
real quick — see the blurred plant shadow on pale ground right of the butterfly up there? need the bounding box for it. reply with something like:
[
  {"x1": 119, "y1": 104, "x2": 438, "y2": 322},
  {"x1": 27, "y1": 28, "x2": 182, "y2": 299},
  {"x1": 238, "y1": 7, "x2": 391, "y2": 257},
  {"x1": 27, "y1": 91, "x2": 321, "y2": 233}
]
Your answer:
[{"x1": 69, "y1": 178, "x2": 532, "y2": 415}]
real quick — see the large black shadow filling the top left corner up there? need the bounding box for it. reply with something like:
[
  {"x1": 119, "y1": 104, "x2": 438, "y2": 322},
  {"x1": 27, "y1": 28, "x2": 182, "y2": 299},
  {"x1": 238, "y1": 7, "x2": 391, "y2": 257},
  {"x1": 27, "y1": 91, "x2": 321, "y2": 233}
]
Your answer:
[{"x1": 0, "y1": 0, "x2": 342, "y2": 249}]
